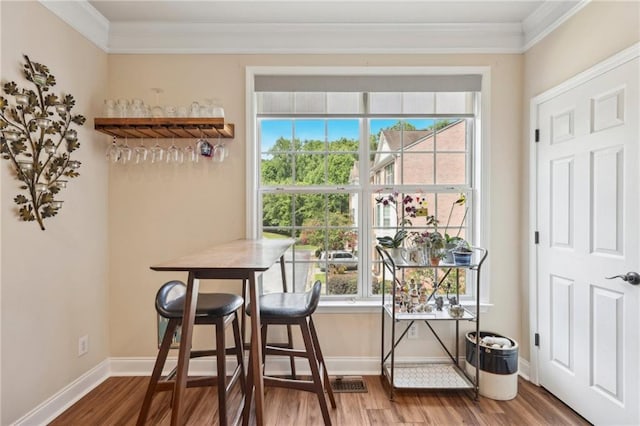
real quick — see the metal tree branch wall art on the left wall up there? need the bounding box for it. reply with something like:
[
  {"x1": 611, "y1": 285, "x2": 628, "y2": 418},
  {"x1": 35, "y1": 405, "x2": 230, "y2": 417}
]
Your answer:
[{"x1": 0, "y1": 55, "x2": 85, "y2": 231}]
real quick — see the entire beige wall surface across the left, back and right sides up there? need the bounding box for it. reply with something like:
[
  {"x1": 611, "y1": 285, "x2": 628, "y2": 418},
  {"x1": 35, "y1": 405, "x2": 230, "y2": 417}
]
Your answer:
[{"x1": 5, "y1": 2, "x2": 640, "y2": 424}]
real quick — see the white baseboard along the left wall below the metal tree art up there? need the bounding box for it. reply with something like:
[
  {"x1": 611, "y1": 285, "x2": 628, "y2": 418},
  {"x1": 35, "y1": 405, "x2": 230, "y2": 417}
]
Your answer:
[{"x1": 12, "y1": 359, "x2": 110, "y2": 426}]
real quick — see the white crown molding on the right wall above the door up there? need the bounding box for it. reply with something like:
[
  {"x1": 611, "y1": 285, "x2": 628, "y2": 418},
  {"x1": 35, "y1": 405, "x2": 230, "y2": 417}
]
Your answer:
[{"x1": 522, "y1": 0, "x2": 591, "y2": 52}]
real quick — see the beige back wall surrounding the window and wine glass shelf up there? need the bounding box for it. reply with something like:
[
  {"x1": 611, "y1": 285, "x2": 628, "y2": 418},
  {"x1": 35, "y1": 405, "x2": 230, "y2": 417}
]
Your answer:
[{"x1": 104, "y1": 55, "x2": 523, "y2": 357}]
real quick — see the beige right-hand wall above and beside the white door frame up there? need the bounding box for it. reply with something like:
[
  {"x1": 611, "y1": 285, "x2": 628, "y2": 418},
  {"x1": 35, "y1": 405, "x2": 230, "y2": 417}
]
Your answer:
[{"x1": 520, "y1": 1, "x2": 640, "y2": 359}]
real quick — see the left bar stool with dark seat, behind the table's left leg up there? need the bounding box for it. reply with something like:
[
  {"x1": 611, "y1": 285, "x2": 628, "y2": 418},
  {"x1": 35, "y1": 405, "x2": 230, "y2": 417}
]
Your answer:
[{"x1": 137, "y1": 281, "x2": 246, "y2": 425}]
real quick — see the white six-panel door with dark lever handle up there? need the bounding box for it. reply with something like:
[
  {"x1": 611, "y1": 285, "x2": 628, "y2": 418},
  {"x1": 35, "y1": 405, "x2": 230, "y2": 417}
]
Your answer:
[{"x1": 536, "y1": 55, "x2": 640, "y2": 425}]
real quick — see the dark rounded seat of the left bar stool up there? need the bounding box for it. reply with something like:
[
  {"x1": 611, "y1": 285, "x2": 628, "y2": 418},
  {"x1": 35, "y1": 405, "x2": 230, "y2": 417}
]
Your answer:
[{"x1": 156, "y1": 281, "x2": 243, "y2": 319}]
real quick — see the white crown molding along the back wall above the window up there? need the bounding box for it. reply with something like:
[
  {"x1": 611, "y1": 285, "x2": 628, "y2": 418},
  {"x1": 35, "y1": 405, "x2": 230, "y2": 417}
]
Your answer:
[{"x1": 109, "y1": 22, "x2": 523, "y2": 54}]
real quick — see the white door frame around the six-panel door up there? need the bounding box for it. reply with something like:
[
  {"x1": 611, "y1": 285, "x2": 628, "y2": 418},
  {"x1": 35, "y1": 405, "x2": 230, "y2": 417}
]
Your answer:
[{"x1": 528, "y1": 42, "x2": 640, "y2": 385}]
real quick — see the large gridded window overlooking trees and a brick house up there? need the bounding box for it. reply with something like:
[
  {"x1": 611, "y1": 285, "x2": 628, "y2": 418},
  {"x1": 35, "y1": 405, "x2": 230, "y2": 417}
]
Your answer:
[{"x1": 250, "y1": 69, "x2": 480, "y2": 300}]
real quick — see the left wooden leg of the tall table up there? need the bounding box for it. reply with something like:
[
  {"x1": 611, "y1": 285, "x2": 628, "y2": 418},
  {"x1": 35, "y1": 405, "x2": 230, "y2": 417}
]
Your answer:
[{"x1": 171, "y1": 272, "x2": 200, "y2": 426}]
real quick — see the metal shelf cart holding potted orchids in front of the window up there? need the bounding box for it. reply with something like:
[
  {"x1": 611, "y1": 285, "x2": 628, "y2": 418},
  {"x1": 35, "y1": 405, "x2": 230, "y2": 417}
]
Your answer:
[{"x1": 376, "y1": 246, "x2": 487, "y2": 400}]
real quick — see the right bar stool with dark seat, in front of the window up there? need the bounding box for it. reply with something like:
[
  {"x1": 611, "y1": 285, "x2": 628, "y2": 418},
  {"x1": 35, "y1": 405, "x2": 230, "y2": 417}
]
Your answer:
[{"x1": 245, "y1": 281, "x2": 336, "y2": 425}]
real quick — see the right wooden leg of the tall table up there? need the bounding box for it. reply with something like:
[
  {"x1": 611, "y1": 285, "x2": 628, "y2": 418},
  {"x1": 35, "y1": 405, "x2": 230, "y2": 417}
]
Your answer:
[{"x1": 249, "y1": 273, "x2": 264, "y2": 426}]
